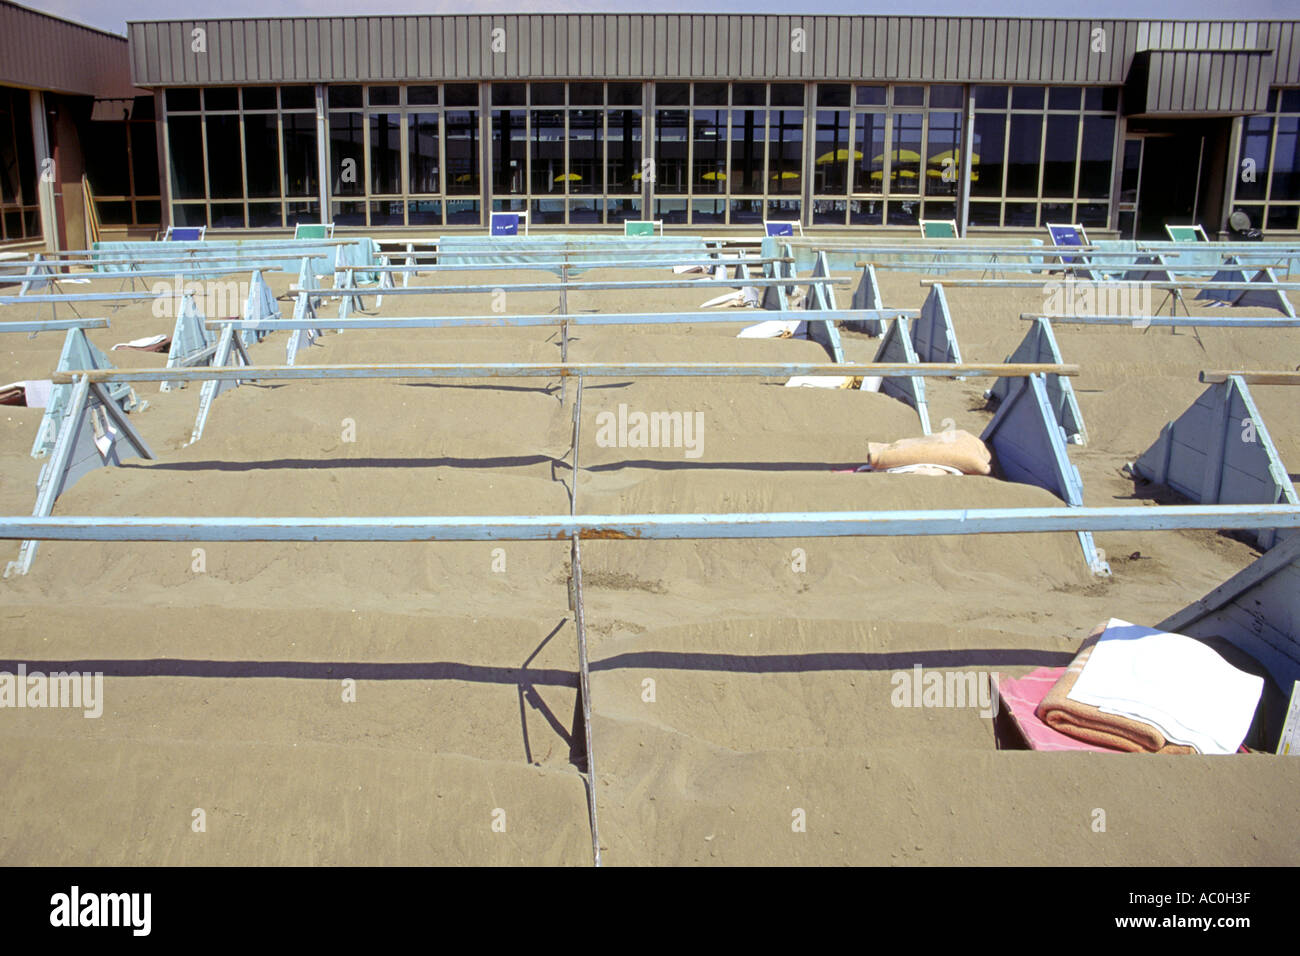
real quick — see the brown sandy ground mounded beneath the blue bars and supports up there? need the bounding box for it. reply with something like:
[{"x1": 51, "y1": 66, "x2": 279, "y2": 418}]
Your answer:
[{"x1": 0, "y1": 264, "x2": 1300, "y2": 865}]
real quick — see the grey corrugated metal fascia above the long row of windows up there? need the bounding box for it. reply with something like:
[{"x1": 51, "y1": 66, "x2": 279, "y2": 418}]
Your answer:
[{"x1": 122, "y1": 13, "x2": 1300, "y2": 92}]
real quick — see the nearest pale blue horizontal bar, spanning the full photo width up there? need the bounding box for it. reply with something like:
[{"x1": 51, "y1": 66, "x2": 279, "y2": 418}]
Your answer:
[{"x1": 0, "y1": 505, "x2": 1300, "y2": 541}]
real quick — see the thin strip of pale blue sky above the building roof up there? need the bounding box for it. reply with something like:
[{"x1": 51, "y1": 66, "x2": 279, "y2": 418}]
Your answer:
[{"x1": 17, "y1": 0, "x2": 1300, "y2": 34}]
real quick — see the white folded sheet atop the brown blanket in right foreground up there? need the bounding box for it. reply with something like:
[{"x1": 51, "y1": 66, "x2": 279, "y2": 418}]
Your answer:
[{"x1": 1070, "y1": 618, "x2": 1264, "y2": 753}]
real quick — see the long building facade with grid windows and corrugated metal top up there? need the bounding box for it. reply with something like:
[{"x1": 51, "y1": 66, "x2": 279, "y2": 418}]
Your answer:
[{"x1": 0, "y1": 12, "x2": 1300, "y2": 247}]
